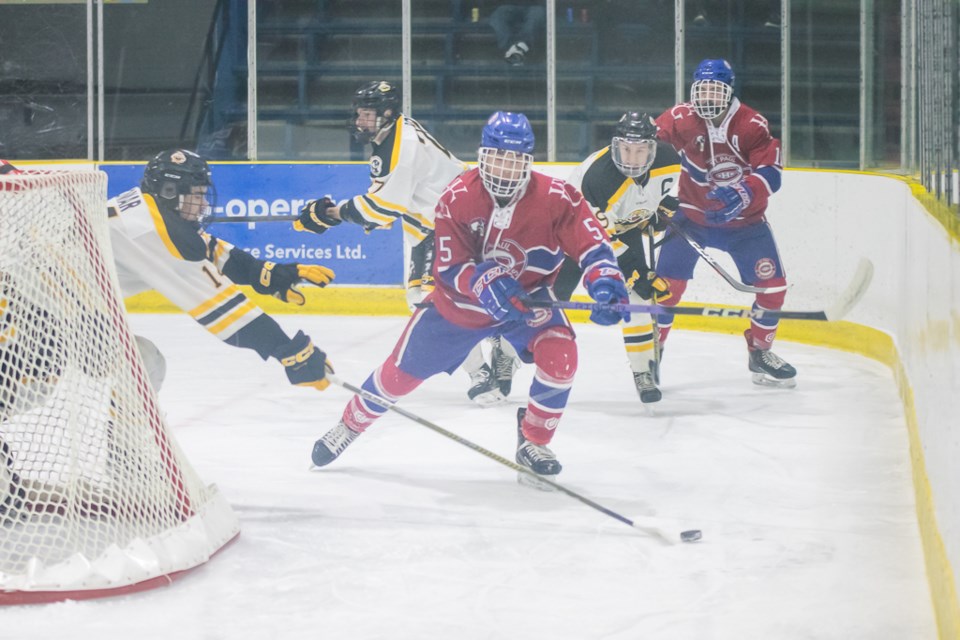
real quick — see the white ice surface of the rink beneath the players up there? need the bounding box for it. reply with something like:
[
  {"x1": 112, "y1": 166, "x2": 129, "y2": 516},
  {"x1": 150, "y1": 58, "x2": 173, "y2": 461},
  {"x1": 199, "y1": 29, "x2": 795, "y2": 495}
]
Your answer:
[{"x1": 0, "y1": 315, "x2": 936, "y2": 640}]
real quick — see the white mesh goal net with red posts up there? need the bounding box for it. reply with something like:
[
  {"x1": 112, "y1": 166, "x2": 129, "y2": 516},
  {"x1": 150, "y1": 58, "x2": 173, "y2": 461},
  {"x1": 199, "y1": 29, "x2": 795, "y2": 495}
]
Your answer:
[{"x1": 0, "y1": 171, "x2": 239, "y2": 604}]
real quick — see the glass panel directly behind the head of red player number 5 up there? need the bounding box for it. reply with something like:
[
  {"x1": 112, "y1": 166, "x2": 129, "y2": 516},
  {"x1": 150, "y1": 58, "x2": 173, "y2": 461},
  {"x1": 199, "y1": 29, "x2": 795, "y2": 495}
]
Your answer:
[{"x1": 410, "y1": 0, "x2": 547, "y2": 162}]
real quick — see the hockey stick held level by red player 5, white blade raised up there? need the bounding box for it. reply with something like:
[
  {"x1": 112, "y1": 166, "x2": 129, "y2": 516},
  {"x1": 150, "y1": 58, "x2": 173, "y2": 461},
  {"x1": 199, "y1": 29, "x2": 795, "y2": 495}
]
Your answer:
[{"x1": 523, "y1": 258, "x2": 873, "y2": 322}]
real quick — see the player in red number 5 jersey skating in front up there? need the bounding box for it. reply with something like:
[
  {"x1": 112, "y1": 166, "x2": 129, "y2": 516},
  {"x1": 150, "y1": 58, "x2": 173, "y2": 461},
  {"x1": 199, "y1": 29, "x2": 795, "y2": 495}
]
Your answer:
[{"x1": 313, "y1": 111, "x2": 629, "y2": 484}]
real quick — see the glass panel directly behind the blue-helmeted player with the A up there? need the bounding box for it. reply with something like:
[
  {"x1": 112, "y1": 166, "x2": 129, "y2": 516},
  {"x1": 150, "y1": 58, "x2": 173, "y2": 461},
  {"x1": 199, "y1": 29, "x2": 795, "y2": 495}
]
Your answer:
[{"x1": 682, "y1": 0, "x2": 782, "y2": 138}]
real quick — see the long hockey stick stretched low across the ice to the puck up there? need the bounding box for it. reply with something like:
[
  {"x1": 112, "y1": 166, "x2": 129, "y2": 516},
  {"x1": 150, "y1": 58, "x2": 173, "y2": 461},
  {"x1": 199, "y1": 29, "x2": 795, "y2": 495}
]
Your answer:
[{"x1": 327, "y1": 374, "x2": 702, "y2": 545}]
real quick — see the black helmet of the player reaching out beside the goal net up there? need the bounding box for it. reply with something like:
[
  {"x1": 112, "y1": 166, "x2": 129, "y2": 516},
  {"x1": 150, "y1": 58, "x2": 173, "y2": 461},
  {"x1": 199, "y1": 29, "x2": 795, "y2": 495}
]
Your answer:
[{"x1": 140, "y1": 149, "x2": 216, "y2": 222}]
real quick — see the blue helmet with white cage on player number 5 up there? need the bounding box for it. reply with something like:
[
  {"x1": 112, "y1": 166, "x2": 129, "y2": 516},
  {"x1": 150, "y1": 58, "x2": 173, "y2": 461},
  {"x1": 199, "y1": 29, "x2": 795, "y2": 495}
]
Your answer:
[{"x1": 478, "y1": 111, "x2": 534, "y2": 198}]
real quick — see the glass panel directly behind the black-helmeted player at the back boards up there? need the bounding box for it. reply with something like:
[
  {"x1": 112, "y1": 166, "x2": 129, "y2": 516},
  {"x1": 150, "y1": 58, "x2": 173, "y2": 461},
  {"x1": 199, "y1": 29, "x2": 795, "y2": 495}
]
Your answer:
[{"x1": 257, "y1": 0, "x2": 402, "y2": 161}]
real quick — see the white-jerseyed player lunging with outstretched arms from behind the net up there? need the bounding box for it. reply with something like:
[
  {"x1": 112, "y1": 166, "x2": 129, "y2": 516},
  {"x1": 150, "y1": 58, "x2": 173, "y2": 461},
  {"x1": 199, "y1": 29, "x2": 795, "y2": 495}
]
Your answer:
[{"x1": 107, "y1": 149, "x2": 334, "y2": 390}]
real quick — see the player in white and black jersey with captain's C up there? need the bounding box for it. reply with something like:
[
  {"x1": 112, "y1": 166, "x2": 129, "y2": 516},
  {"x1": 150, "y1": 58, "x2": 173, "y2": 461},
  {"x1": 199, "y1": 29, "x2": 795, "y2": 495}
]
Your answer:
[{"x1": 556, "y1": 111, "x2": 680, "y2": 403}]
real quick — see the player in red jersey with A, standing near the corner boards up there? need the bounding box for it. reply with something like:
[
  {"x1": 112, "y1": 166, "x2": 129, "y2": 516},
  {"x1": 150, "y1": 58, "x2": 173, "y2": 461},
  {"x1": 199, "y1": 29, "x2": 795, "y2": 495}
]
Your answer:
[{"x1": 657, "y1": 59, "x2": 797, "y2": 387}]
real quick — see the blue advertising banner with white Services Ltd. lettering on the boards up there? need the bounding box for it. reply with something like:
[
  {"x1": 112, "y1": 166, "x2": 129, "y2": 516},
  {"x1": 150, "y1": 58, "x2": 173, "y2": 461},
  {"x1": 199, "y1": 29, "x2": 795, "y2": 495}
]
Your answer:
[{"x1": 100, "y1": 163, "x2": 404, "y2": 286}]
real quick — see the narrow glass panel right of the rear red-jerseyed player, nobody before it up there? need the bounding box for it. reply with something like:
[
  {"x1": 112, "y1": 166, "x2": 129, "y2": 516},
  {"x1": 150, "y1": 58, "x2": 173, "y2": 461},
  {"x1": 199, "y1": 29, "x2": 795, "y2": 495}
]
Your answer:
[{"x1": 790, "y1": 0, "x2": 860, "y2": 169}]
